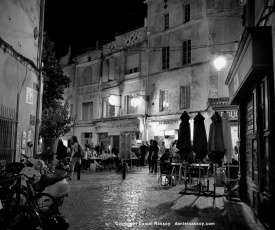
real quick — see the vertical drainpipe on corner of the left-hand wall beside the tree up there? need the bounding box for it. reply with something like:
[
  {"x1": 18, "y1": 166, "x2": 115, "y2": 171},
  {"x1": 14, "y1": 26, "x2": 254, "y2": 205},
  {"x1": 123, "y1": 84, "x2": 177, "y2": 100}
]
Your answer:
[{"x1": 33, "y1": 0, "x2": 45, "y2": 154}]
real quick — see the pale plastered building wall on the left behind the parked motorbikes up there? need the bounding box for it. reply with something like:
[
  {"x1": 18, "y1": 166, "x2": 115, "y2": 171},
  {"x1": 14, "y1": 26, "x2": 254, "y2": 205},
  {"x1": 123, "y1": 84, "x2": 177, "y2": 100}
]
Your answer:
[{"x1": 0, "y1": 0, "x2": 44, "y2": 165}]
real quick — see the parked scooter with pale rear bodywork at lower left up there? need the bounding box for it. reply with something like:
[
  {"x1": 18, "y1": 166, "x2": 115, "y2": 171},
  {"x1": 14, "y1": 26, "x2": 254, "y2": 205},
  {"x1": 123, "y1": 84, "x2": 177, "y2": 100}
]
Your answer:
[{"x1": 20, "y1": 154, "x2": 70, "y2": 206}]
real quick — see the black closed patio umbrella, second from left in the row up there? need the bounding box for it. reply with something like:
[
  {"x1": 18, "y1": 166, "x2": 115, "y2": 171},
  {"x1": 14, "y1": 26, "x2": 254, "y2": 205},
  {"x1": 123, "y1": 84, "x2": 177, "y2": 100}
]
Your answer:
[{"x1": 193, "y1": 112, "x2": 207, "y2": 162}]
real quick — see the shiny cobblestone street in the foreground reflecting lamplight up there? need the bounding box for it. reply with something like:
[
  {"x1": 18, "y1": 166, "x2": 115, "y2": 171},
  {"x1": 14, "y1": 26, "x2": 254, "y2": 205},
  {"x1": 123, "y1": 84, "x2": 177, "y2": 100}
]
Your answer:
[{"x1": 60, "y1": 167, "x2": 229, "y2": 230}]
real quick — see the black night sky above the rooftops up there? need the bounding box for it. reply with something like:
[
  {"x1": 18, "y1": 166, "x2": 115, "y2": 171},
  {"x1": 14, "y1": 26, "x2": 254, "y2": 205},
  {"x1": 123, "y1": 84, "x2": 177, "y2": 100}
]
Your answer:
[{"x1": 44, "y1": 0, "x2": 147, "y2": 57}]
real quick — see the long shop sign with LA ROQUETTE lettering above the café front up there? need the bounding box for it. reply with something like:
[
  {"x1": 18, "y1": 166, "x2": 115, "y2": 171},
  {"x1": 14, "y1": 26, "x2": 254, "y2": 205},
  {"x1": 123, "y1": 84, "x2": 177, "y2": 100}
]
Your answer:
[{"x1": 96, "y1": 119, "x2": 140, "y2": 133}]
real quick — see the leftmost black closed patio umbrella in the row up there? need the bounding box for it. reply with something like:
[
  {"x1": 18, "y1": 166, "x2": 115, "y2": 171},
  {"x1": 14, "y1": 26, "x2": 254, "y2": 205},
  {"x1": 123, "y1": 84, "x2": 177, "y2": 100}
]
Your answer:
[{"x1": 176, "y1": 111, "x2": 191, "y2": 160}]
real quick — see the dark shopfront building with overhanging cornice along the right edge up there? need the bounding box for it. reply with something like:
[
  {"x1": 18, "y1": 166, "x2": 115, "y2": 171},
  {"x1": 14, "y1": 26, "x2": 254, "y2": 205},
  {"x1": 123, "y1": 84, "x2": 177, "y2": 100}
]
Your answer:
[{"x1": 226, "y1": 1, "x2": 275, "y2": 229}]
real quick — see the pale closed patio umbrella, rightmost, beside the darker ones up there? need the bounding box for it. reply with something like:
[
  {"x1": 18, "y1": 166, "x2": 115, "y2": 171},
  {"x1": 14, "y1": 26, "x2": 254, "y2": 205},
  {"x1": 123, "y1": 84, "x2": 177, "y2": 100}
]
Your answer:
[{"x1": 222, "y1": 112, "x2": 233, "y2": 163}]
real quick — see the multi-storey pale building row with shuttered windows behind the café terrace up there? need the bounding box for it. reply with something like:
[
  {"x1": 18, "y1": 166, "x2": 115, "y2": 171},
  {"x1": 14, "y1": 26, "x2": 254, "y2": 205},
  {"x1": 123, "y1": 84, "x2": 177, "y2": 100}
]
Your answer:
[{"x1": 64, "y1": 0, "x2": 241, "y2": 158}]
